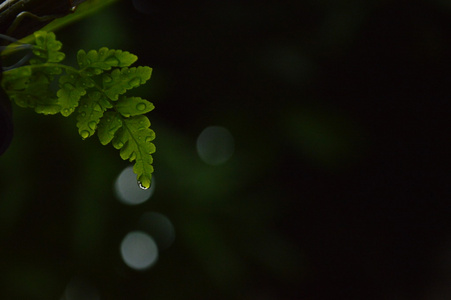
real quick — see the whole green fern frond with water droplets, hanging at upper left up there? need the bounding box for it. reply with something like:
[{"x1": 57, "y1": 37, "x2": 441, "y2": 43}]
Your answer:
[{"x1": 2, "y1": 31, "x2": 155, "y2": 188}]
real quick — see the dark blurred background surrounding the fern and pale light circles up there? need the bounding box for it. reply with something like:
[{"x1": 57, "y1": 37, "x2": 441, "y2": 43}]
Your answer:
[{"x1": 0, "y1": 0, "x2": 451, "y2": 300}]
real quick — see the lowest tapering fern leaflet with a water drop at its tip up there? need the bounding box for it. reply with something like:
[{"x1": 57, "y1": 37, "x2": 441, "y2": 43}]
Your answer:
[{"x1": 113, "y1": 115, "x2": 155, "y2": 188}]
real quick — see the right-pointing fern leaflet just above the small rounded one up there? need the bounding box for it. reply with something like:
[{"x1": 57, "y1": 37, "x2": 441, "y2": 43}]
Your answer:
[{"x1": 103, "y1": 67, "x2": 152, "y2": 101}]
